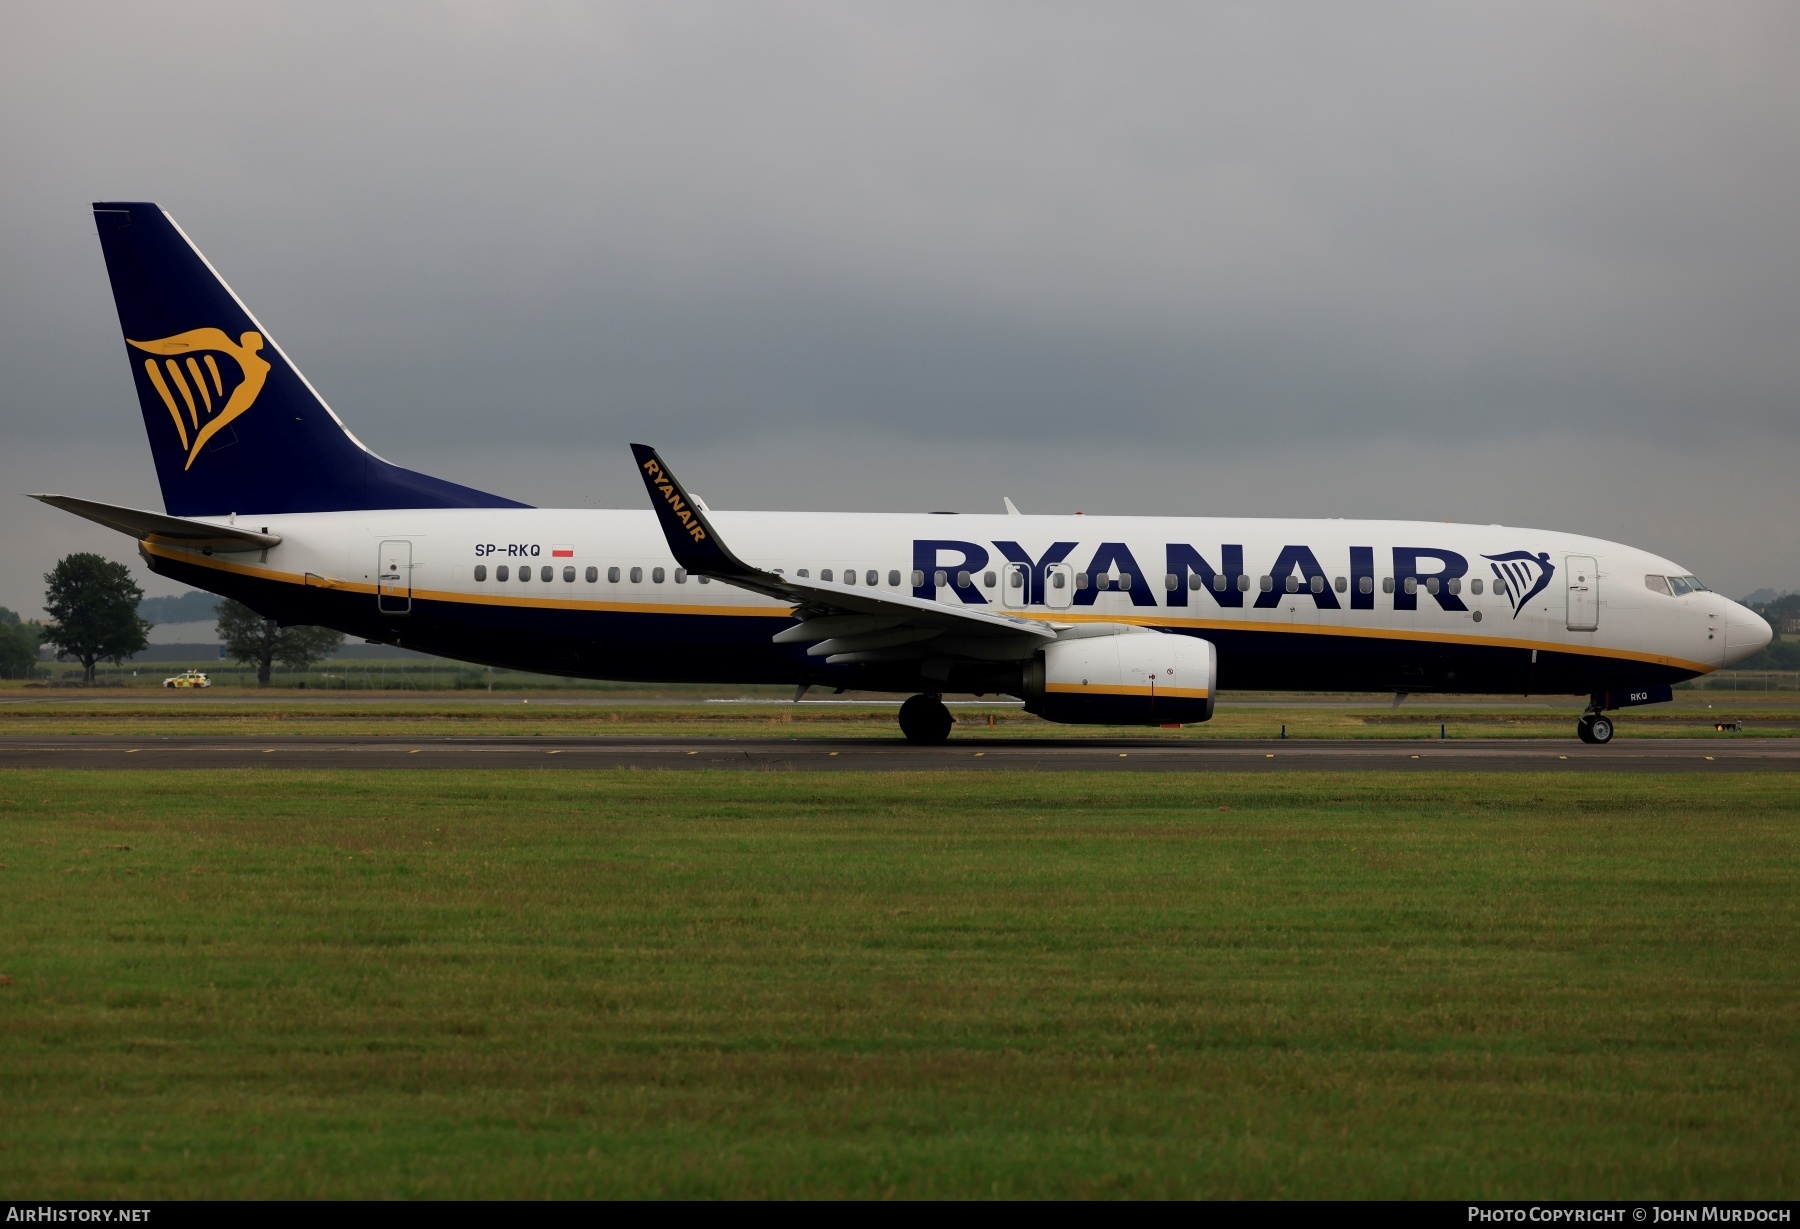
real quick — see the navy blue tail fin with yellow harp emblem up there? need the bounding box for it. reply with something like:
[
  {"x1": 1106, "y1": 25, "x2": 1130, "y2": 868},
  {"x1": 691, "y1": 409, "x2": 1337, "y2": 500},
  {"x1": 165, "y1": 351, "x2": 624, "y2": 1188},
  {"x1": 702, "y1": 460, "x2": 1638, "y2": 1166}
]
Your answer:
[{"x1": 94, "y1": 202, "x2": 526, "y2": 516}]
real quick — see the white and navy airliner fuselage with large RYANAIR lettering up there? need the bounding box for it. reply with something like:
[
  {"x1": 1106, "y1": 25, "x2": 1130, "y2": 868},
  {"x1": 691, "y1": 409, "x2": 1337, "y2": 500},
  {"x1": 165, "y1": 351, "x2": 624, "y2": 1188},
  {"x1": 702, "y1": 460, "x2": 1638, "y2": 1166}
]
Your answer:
[{"x1": 146, "y1": 509, "x2": 1768, "y2": 691}]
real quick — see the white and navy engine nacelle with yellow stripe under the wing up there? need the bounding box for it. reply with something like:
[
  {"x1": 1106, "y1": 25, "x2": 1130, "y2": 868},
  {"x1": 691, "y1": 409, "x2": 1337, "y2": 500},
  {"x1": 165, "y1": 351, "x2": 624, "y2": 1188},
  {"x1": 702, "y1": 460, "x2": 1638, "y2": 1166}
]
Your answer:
[{"x1": 1024, "y1": 632, "x2": 1219, "y2": 725}]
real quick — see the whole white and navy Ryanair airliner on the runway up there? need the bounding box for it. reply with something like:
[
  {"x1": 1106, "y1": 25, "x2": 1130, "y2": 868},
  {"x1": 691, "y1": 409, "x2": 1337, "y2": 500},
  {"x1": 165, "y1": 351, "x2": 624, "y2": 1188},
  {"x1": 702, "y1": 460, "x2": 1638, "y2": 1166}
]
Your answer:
[{"x1": 36, "y1": 202, "x2": 1769, "y2": 743}]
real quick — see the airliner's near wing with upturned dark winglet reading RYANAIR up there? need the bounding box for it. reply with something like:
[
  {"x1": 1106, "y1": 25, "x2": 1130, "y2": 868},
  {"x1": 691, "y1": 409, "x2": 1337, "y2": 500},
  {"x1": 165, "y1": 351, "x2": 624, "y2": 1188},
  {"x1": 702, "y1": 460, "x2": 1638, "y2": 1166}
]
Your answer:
[{"x1": 632, "y1": 444, "x2": 1057, "y2": 666}]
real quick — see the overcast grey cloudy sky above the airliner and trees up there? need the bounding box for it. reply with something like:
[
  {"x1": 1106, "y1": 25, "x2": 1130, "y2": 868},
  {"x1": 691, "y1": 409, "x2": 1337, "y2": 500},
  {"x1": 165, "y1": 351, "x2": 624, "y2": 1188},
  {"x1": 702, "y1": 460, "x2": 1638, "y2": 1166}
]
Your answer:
[{"x1": 0, "y1": 0, "x2": 1800, "y2": 612}]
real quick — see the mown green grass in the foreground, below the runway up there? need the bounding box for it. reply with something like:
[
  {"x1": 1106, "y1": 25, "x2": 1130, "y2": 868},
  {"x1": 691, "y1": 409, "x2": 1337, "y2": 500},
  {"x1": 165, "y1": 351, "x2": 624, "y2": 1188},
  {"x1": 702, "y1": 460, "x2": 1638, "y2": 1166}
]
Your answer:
[{"x1": 0, "y1": 770, "x2": 1800, "y2": 1198}]
